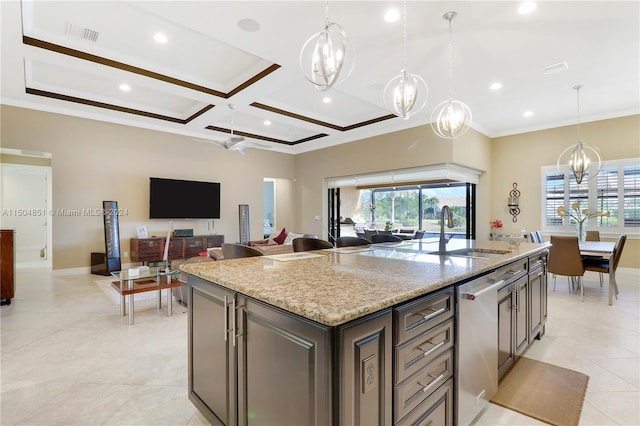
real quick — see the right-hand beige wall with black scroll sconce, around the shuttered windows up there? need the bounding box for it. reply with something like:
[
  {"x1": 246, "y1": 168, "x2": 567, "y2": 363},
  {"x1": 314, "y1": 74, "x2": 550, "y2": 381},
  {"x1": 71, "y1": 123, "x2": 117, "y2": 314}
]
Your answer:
[{"x1": 491, "y1": 115, "x2": 640, "y2": 268}]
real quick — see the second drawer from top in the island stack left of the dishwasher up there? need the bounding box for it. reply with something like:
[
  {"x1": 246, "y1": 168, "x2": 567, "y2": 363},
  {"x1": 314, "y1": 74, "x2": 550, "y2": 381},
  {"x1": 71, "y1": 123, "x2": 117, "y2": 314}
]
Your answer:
[{"x1": 394, "y1": 318, "x2": 453, "y2": 384}]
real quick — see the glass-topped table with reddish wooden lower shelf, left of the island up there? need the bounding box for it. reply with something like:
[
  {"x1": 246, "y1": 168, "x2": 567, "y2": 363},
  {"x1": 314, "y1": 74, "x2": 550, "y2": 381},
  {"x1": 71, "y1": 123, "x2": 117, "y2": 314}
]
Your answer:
[{"x1": 111, "y1": 268, "x2": 182, "y2": 325}]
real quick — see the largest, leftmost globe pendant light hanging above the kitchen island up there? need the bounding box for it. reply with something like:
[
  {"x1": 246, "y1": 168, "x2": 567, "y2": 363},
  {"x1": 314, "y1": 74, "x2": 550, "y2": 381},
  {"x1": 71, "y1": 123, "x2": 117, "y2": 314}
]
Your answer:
[{"x1": 300, "y1": 1, "x2": 356, "y2": 91}]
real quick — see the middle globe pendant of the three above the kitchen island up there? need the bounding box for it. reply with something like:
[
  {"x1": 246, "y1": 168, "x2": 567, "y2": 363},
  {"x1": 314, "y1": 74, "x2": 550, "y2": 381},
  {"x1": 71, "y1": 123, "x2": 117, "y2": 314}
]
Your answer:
[{"x1": 383, "y1": 1, "x2": 429, "y2": 120}]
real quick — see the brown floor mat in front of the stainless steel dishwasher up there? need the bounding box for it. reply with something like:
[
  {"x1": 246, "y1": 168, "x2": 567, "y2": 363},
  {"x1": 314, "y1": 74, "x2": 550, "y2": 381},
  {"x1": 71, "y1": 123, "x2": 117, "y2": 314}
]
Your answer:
[{"x1": 491, "y1": 357, "x2": 589, "y2": 426}]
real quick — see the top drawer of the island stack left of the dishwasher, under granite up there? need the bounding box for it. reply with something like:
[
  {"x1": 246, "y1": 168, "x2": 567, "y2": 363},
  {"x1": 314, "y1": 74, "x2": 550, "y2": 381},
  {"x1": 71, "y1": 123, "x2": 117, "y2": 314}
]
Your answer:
[{"x1": 393, "y1": 287, "x2": 453, "y2": 345}]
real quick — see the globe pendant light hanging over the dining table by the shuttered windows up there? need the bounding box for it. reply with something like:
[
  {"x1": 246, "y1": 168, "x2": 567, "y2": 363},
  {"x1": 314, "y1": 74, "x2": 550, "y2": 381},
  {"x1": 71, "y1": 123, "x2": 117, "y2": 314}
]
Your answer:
[{"x1": 556, "y1": 84, "x2": 602, "y2": 185}]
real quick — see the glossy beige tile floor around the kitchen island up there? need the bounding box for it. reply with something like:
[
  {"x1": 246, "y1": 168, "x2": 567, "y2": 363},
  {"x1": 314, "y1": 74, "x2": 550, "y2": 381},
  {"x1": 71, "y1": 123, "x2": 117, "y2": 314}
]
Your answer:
[{"x1": 0, "y1": 268, "x2": 640, "y2": 426}]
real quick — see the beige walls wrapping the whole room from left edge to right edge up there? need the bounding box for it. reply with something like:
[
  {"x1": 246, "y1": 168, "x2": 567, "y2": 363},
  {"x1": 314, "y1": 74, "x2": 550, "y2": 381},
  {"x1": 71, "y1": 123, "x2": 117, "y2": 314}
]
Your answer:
[{"x1": 1, "y1": 106, "x2": 640, "y2": 269}]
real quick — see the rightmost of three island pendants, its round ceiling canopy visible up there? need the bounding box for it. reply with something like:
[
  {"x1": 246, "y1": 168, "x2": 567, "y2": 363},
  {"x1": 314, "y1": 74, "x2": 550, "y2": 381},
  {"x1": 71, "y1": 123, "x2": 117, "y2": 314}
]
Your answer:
[{"x1": 431, "y1": 12, "x2": 471, "y2": 139}]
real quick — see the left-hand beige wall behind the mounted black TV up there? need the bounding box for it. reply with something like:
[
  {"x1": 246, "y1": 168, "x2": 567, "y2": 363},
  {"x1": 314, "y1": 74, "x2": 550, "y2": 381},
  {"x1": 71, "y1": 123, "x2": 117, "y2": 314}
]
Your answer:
[{"x1": 1, "y1": 105, "x2": 295, "y2": 269}]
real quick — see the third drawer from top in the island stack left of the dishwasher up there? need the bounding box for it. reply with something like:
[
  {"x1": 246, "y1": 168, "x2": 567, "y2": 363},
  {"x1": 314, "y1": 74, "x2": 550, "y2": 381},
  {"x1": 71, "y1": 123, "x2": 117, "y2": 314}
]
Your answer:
[{"x1": 393, "y1": 350, "x2": 453, "y2": 422}]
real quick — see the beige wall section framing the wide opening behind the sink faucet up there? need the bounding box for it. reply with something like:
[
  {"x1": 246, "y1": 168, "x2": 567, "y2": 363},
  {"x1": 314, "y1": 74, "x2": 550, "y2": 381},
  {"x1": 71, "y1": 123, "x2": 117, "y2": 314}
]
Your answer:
[{"x1": 295, "y1": 126, "x2": 491, "y2": 238}]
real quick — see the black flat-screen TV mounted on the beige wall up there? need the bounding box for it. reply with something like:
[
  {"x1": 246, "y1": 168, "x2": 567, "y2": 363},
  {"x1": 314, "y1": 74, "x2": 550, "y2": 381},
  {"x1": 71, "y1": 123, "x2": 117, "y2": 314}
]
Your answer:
[{"x1": 149, "y1": 177, "x2": 220, "y2": 219}]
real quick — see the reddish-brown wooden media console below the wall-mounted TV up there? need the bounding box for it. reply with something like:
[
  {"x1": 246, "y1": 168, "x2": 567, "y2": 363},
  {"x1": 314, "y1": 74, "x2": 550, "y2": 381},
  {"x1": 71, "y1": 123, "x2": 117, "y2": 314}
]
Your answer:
[{"x1": 129, "y1": 235, "x2": 224, "y2": 262}]
